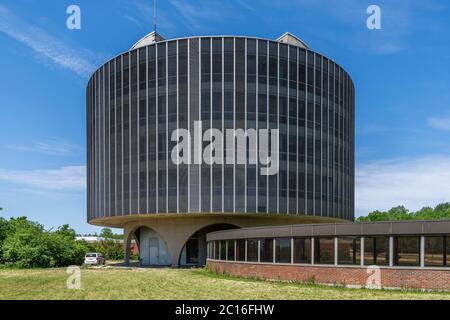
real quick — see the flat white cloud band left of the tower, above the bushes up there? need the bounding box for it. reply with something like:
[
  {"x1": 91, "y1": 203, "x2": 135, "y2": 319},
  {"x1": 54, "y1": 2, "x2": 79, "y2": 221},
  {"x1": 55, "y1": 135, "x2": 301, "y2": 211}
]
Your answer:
[{"x1": 0, "y1": 166, "x2": 86, "y2": 191}]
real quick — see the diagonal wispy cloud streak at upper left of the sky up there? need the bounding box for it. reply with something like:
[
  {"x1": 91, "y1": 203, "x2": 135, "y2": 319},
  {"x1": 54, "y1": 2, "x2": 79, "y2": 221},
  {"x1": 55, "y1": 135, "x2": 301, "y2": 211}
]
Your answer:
[{"x1": 0, "y1": 5, "x2": 100, "y2": 77}]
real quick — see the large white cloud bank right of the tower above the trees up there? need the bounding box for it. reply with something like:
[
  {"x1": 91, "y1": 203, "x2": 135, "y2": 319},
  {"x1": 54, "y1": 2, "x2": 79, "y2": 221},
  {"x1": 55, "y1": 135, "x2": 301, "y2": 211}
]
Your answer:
[{"x1": 356, "y1": 156, "x2": 450, "y2": 216}]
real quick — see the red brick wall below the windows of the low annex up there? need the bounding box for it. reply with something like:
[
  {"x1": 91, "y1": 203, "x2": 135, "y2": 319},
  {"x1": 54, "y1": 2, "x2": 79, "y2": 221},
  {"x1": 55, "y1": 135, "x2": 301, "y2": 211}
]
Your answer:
[{"x1": 207, "y1": 260, "x2": 450, "y2": 291}]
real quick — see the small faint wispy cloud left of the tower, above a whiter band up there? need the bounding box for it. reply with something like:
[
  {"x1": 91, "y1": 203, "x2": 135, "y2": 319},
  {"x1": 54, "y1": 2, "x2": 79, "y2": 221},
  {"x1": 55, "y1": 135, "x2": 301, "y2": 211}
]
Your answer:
[{"x1": 7, "y1": 139, "x2": 80, "y2": 156}]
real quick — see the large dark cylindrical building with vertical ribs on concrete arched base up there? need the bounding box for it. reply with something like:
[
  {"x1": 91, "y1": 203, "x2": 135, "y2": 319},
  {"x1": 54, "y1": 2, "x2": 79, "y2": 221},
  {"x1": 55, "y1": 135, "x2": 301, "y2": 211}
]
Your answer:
[{"x1": 87, "y1": 32, "x2": 355, "y2": 266}]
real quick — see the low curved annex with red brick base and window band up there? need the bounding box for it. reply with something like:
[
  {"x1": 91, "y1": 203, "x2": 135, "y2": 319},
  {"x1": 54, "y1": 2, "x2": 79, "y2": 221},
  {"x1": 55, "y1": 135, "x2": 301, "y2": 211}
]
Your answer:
[{"x1": 207, "y1": 221, "x2": 450, "y2": 290}]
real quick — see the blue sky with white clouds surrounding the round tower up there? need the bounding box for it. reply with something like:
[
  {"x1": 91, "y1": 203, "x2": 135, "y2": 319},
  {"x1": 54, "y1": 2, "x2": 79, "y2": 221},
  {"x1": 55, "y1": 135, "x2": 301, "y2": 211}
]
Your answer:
[{"x1": 0, "y1": 0, "x2": 450, "y2": 233}]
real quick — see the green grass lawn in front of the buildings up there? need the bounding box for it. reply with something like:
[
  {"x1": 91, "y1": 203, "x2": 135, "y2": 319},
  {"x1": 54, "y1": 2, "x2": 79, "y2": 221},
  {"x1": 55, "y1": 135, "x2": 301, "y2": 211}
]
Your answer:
[{"x1": 0, "y1": 267, "x2": 450, "y2": 300}]
